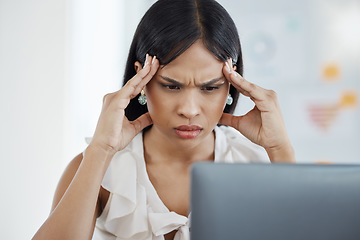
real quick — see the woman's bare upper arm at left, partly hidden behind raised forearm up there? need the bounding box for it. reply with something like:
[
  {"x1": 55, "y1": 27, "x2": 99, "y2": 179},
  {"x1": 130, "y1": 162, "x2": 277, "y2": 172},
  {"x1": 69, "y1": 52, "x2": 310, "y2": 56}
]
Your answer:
[{"x1": 51, "y1": 153, "x2": 109, "y2": 216}]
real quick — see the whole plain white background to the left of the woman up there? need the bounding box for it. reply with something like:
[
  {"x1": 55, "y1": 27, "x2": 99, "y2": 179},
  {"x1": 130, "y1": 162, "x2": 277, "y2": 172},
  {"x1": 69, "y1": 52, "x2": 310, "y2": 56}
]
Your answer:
[{"x1": 0, "y1": 0, "x2": 154, "y2": 239}]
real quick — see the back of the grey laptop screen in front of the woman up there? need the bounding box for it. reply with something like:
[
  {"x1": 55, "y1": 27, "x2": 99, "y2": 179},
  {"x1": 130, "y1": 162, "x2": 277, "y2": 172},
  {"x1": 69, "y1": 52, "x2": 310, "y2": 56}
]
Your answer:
[{"x1": 190, "y1": 163, "x2": 360, "y2": 240}]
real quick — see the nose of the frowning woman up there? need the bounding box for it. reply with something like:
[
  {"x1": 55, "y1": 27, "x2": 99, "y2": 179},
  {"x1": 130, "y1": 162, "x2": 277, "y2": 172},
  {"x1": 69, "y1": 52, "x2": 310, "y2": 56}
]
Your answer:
[{"x1": 177, "y1": 90, "x2": 201, "y2": 119}]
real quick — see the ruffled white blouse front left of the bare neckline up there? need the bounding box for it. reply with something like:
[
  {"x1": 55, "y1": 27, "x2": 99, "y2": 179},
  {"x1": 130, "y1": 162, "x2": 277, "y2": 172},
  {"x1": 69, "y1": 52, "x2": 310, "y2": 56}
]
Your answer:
[{"x1": 93, "y1": 134, "x2": 190, "y2": 240}]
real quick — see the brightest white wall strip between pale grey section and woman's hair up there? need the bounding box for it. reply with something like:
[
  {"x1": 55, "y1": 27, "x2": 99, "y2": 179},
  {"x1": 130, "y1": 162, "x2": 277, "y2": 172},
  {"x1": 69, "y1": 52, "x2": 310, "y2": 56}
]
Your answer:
[{"x1": 65, "y1": 0, "x2": 153, "y2": 161}]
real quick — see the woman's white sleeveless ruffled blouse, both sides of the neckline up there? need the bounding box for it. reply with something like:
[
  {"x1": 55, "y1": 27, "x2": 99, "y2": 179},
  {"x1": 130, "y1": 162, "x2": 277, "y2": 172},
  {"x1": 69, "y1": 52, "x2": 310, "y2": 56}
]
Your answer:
[{"x1": 92, "y1": 126, "x2": 270, "y2": 240}]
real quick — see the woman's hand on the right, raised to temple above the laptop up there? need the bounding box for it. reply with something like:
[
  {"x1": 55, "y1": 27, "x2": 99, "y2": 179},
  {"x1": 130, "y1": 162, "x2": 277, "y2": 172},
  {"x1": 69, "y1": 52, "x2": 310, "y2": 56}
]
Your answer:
[{"x1": 219, "y1": 59, "x2": 295, "y2": 162}]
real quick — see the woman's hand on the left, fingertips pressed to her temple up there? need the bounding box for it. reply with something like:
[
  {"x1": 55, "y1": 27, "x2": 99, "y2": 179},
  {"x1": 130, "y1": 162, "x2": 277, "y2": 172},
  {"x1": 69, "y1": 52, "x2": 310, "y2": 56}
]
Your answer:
[{"x1": 89, "y1": 54, "x2": 159, "y2": 154}]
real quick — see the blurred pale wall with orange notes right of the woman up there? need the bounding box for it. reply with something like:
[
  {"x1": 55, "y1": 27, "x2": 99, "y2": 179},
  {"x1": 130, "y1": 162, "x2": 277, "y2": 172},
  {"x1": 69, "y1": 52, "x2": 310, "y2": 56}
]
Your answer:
[{"x1": 219, "y1": 0, "x2": 360, "y2": 163}]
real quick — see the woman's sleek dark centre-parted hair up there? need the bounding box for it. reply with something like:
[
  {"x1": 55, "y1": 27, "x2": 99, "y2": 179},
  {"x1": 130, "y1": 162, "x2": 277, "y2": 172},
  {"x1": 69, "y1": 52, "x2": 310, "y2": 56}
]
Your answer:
[{"x1": 123, "y1": 0, "x2": 243, "y2": 121}]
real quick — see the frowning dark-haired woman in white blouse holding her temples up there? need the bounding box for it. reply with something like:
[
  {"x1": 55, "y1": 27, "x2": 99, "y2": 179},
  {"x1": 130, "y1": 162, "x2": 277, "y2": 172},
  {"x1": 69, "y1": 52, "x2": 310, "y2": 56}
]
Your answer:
[{"x1": 34, "y1": 0, "x2": 294, "y2": 240}]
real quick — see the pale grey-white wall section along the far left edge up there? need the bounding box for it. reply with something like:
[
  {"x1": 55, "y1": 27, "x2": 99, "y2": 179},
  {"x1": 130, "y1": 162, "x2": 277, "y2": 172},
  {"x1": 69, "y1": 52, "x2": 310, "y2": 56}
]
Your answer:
[{"x1": 0, "y1": 0, "x2": 66, "y2": 239}]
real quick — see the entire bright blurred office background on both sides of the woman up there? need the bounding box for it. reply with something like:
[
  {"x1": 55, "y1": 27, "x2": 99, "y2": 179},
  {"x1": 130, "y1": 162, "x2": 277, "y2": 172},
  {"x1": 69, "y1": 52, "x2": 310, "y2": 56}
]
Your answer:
[{"x1": 0, "y1": 0, "x2": 360, "y2": 239}]
